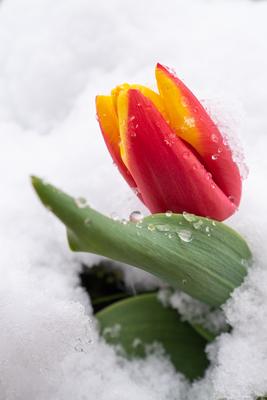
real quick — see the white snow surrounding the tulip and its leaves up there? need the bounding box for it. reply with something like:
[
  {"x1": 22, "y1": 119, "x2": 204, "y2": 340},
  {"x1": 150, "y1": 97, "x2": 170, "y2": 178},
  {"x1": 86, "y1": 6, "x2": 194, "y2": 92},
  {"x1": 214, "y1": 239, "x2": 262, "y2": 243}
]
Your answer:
[{"x1": 0, "y1": 0, "x2": 267, "y2": 400}]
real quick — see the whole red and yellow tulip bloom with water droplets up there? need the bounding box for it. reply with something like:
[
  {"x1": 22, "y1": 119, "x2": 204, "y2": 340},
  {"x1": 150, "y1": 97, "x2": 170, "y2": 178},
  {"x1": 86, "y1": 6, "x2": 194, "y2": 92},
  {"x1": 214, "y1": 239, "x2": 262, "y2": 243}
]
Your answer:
[{"x1": 96, "y1": 64, "x2": 241, "y2": 221}]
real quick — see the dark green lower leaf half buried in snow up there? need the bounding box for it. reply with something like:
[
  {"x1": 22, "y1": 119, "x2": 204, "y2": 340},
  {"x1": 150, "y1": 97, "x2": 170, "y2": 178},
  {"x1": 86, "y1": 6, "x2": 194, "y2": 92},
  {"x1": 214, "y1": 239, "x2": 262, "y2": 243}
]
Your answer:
[{"x1": 96, "y1": 294, "x2": 208, "y2": 380}]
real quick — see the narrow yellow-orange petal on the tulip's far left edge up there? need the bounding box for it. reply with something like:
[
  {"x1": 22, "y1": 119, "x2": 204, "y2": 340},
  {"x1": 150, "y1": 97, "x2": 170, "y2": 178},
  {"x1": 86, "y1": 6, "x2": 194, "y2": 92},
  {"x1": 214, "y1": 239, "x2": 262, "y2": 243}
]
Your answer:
[{"x1": 96, "y1": 96, "x2": 136, "y2": 188}]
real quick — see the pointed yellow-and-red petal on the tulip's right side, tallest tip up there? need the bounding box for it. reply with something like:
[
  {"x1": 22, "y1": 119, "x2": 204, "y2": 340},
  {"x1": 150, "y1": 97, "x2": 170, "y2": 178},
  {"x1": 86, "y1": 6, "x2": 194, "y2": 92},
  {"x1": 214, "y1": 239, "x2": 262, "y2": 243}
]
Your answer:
[{"x1": 156, "y1": 64, "x2": 242, "y2": 206}]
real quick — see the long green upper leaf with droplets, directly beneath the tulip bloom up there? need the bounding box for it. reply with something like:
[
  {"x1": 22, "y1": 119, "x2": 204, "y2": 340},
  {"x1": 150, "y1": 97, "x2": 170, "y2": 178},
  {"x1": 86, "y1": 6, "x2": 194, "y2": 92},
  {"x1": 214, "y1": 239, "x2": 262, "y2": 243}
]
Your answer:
[{"x1": 32, "y1": 178, "x2": 251, "y2": 306}]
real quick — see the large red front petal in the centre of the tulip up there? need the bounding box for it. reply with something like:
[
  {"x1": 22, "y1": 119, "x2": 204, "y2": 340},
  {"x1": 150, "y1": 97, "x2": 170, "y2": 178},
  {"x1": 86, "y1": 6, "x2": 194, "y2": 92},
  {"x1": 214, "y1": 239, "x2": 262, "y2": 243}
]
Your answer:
[{"x1": 119, "y1": 89, "x2": 236, "y2": 221}]
